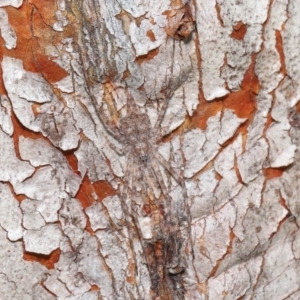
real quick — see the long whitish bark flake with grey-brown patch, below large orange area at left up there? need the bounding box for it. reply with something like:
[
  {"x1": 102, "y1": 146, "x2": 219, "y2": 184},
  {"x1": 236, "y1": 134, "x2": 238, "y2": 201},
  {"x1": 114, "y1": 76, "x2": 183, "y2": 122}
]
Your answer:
[{"x1": 2, "y1": 57, "x2": 79, "y2": 150}]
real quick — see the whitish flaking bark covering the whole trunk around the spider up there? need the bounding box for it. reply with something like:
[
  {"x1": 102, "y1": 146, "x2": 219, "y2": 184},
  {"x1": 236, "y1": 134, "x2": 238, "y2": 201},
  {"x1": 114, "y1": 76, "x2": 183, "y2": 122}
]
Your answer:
[{"x1": 0, "y1": 0, "x2": 300, "y2": 300}]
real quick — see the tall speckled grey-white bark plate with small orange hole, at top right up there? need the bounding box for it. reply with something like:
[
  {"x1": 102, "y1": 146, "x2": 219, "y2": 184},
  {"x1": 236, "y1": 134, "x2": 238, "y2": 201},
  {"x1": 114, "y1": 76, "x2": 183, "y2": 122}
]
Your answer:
[{"x1": 196, "y1": 0, "x2": 269, "y2": 101}]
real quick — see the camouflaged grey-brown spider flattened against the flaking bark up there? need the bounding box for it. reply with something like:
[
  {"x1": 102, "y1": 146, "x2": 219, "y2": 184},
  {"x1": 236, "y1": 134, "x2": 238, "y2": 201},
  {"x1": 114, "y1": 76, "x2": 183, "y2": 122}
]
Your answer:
[{"x1": 100, "y1": 94, "x2": 183, "y2": 204}]
